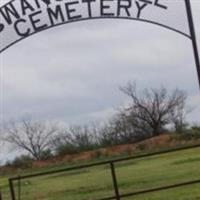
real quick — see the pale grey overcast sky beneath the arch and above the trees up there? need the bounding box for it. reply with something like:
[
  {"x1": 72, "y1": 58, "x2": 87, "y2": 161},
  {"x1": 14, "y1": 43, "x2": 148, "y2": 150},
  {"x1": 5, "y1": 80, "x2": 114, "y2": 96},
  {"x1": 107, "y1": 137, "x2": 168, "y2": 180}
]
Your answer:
[{"x1": 0, "y1": 0, "x2": 200, "y2": 163}]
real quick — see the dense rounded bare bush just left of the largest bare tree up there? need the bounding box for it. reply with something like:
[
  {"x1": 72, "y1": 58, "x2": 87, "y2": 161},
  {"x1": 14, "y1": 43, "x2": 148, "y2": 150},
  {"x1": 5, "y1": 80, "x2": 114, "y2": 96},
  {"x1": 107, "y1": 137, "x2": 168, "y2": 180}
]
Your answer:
[{"x1": 99, "y1": 110, "x2": 150, "y2": 146}]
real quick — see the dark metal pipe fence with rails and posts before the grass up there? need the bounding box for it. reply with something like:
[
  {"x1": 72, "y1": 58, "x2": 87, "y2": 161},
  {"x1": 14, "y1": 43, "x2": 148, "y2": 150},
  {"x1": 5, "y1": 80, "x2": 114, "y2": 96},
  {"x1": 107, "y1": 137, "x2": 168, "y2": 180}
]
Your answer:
[{"x1": 8, "y1": 144, "x2": 200, "y2": 200}]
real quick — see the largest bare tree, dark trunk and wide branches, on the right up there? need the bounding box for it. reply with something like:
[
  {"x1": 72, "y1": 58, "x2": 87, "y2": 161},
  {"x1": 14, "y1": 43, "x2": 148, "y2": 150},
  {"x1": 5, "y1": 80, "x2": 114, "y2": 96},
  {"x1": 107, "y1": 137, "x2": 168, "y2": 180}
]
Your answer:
[{"x1": 120, "y1": 82, "x2": 187, "y2": 136}]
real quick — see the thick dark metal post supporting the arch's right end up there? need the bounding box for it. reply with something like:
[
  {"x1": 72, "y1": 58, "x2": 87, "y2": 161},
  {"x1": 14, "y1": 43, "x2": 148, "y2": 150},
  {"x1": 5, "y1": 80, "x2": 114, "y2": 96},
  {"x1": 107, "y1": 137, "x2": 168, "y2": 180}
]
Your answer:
[{"x1": 185, "y1": 0, "x2": 200, "y2": 87}]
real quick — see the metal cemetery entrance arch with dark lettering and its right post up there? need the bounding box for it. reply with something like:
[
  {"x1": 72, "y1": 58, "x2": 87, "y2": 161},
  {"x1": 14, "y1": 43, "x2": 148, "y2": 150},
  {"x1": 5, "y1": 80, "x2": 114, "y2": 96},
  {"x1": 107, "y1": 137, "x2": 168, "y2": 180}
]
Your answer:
[{"x1": 0, "y1": 0, "x2": 200, "y2": 89}]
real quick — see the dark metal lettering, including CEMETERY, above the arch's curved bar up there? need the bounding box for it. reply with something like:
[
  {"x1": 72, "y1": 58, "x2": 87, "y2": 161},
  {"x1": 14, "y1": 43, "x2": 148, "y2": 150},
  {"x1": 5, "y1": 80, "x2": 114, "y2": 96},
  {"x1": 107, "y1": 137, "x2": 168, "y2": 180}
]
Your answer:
[{"x1": 0, "y1": 0, "x2": 167, "y2": 37}]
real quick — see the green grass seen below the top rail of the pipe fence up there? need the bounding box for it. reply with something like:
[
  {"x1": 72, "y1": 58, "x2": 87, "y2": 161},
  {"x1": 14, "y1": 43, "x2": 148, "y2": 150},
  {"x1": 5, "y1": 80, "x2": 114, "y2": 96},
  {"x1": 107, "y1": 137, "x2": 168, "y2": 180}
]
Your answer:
[{"x1": 0, "y1": 148, "x2": 200, "y2": 200}]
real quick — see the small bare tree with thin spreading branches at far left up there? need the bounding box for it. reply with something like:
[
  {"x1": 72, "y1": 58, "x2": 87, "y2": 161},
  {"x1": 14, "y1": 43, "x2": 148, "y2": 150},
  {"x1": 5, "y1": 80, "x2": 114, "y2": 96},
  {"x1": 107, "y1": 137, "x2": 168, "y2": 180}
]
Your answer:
[{"x1": 4, "y1": 119, "x2": 57, "y2": 160}]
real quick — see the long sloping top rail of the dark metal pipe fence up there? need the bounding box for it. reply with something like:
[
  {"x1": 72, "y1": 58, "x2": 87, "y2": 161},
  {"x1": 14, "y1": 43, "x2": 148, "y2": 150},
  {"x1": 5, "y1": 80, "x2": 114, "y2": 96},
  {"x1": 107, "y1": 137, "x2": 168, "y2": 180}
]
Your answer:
[{"x1": 9, "y1": 144, "x2": 200, "y2": 181}]
